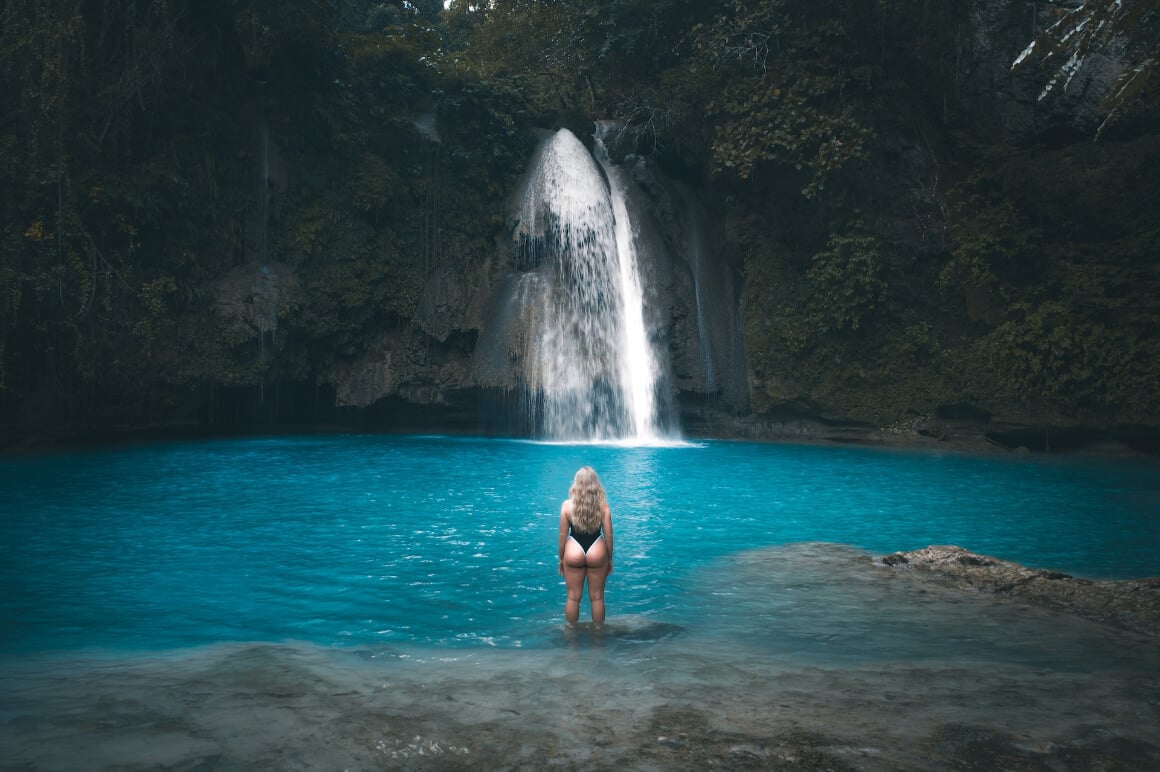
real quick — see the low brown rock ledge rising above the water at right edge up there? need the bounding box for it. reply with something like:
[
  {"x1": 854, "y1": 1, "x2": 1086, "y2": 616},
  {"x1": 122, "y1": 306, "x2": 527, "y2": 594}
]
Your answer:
[{"x1": 882, "y1": 537, "x2": 1160, "y2": 636}]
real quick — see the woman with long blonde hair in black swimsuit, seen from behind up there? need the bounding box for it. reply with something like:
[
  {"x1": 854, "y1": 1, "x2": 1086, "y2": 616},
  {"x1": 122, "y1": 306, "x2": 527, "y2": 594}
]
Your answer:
[{"x1": 560, "y1": 466, "x2": 612, "y2": 627}]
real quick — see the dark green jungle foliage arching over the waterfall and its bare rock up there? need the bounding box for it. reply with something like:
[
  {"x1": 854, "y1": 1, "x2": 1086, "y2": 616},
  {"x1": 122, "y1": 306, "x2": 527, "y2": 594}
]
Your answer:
[{"x1": 0, "y1": 0, "x2": 1160, "y2": 438}]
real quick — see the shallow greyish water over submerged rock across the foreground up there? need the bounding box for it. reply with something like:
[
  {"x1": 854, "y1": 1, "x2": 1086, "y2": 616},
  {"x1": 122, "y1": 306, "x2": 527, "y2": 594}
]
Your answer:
[{"x1": 0, "y1": 545, "x2": 1160, "y2": 770}]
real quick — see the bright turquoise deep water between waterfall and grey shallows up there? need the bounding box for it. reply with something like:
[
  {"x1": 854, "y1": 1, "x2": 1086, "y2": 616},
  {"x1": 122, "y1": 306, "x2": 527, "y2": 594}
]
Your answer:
[{"x1": 0, "y1": 436, "x2": 1160, "y2": 656}]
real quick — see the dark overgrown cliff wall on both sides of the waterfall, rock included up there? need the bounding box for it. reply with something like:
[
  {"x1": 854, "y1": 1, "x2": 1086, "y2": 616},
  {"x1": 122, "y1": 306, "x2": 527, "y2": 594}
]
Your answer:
[{"x1": 0, "y1": 0, "x2": 1160, "y2": 450}]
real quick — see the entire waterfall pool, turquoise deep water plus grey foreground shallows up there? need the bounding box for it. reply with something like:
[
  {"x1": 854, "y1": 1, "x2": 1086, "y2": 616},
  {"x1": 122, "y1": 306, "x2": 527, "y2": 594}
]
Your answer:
[{"x1": 0, "y1": 435, "x2": 1160, "y2": 769}]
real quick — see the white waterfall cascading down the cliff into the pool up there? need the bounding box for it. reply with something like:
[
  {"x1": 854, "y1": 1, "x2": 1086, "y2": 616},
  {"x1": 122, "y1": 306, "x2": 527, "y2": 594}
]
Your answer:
[{"x1": 516, "y1": 126, "x2": 666, "y2": 443}]
